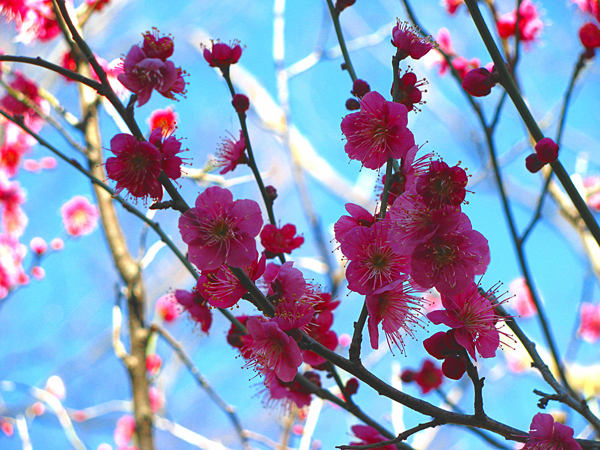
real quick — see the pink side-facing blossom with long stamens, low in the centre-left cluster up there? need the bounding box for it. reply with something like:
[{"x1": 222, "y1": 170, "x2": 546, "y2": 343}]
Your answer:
[{"x1": 243, "y1": 317, "x2": 302, "y2": 386}]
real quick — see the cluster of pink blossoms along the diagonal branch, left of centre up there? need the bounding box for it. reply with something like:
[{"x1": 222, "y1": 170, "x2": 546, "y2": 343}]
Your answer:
[{"x1": 175, "y1": 186, "x2": 339, "y2": 406}]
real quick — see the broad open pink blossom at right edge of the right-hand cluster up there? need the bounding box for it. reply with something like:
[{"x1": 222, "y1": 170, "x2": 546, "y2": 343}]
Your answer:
[{"x1": 410, "y1": 214, "x2": 490, "y2": 295}]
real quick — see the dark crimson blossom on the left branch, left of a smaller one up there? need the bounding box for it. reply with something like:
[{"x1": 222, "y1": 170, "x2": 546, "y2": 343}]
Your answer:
[{"x1": 106, "y1": 133, "x2": 163, "y2": 201}]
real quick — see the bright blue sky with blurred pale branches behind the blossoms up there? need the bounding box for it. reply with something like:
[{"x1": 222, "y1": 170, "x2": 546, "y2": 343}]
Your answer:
[{"x1": 0, "y1": 0, "x2": 600, "y2": 450}]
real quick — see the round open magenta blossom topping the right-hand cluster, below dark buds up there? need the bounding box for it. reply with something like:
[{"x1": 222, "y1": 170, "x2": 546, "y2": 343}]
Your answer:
[{"x1": 341, "y1": 91, "x2": 415, "y2": 169}]
